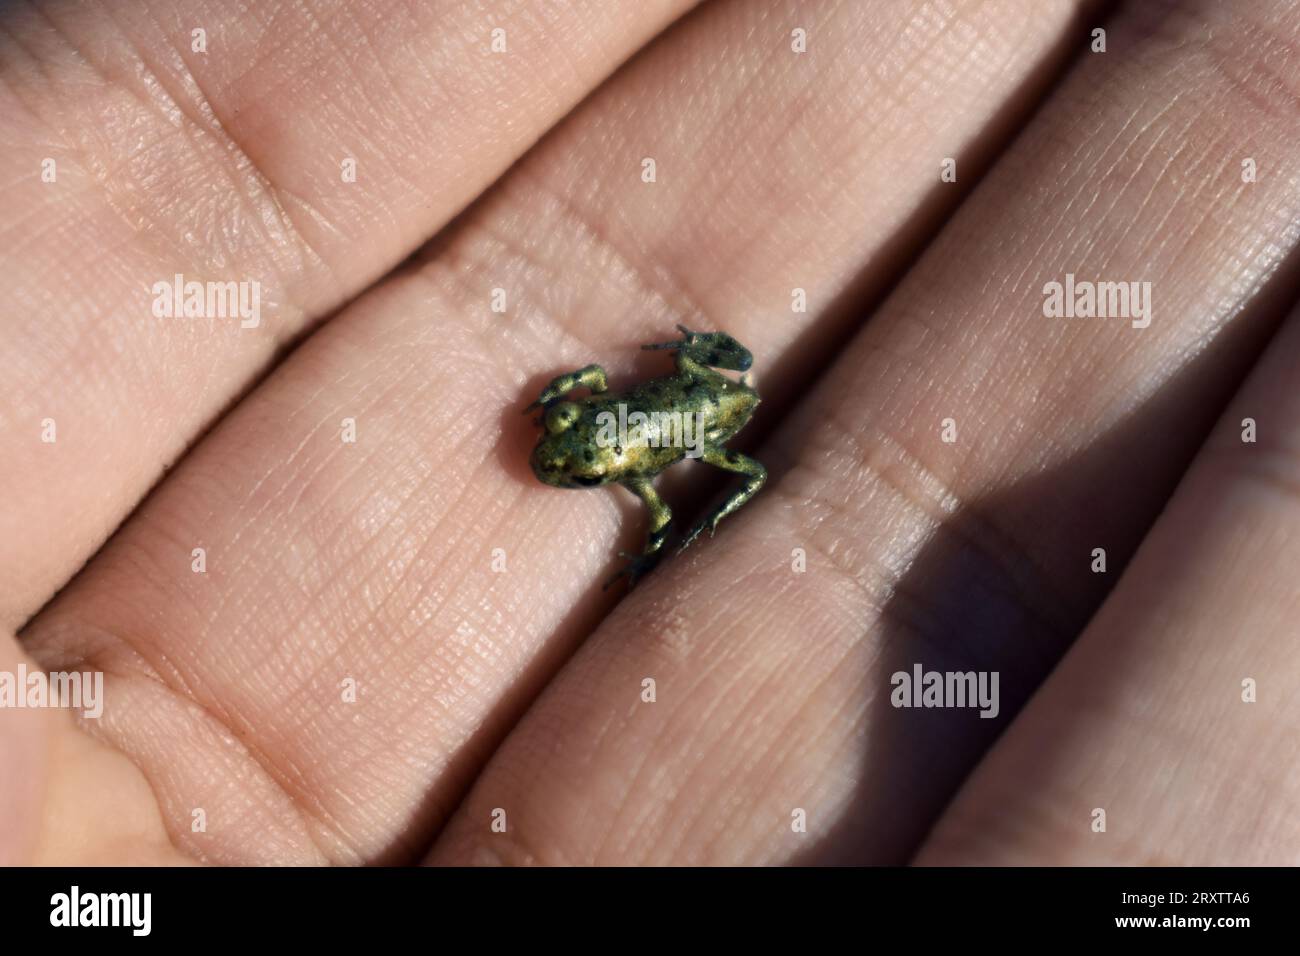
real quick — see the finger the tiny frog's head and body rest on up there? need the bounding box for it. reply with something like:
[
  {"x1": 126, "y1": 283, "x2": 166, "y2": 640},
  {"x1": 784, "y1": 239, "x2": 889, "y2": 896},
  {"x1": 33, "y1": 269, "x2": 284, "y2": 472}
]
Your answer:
[{"x1": 20, "y1": 3, "x2": 1097, "y2": 860}]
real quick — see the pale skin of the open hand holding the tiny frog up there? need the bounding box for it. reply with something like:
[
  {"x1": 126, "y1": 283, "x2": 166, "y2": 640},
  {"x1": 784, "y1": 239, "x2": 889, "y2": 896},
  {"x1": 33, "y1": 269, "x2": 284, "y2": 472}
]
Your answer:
[{"x1": 0, "y1": 0, "x2": 1300, "y2": 864}]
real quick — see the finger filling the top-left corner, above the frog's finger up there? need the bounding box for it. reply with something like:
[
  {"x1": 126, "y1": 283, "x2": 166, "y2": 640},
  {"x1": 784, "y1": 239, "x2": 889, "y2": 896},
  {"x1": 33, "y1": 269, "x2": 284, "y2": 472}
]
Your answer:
[{"x1": 0, "y1": 0, "x2": 688, "y2": 628}]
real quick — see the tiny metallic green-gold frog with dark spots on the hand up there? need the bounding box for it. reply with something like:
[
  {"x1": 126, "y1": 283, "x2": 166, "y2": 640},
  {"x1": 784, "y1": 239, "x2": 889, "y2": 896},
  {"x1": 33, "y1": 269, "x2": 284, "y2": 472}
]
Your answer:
[{"x1": 524, "y1": 325, "x2": 767, "y2": 588}]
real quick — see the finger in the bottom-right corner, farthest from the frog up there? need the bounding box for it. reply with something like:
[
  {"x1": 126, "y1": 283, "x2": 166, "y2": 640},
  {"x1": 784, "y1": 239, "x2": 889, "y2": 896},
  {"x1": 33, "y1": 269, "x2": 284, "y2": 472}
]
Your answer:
[{"x1": 920, "y1": 304, "x2": 1300, "y2": 866}]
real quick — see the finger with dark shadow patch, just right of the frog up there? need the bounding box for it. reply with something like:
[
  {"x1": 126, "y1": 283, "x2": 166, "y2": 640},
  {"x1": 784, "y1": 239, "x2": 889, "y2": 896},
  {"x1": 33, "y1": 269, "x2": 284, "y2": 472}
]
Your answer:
[{"x1": 433, "y1": 4, "x2": 1300, "y2": 864}]
